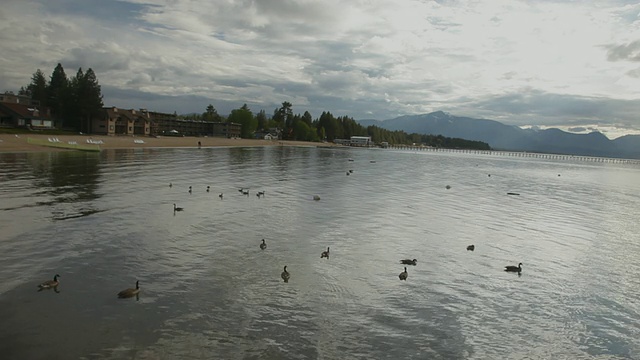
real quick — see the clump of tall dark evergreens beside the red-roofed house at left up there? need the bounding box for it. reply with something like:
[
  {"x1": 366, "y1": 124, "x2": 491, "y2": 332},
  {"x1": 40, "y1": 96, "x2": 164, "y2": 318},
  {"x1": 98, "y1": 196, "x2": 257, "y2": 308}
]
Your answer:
[{"x1": 18, "y1": 63, "x2": 103, "y2": 132}]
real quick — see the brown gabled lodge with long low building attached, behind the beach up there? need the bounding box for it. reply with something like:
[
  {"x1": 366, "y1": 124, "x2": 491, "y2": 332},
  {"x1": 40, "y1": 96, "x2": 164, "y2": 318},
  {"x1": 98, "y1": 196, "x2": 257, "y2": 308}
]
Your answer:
[{"x1": 91, "y1": 106, "x2": 242, "y2": 138}]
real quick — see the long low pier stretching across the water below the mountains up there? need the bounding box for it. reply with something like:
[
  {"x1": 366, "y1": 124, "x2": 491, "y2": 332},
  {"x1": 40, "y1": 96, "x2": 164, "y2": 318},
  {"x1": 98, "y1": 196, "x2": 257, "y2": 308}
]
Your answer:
[{"x1": 385, "y1": 145, "x2": 640, "y2": 165}]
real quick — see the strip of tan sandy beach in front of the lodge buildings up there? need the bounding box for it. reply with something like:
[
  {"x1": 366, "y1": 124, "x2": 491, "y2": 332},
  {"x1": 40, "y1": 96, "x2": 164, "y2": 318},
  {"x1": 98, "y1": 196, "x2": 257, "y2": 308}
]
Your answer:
[{"x1": 0, "y1": 134, "x2": 335, "y2": 152}]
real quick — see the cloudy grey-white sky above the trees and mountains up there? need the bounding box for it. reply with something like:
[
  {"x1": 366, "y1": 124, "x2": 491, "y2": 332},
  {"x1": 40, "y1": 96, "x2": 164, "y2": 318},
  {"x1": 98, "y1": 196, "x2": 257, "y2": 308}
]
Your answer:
[{"x1": 0, "y1": 0, "x2": 640, "y2": 138}]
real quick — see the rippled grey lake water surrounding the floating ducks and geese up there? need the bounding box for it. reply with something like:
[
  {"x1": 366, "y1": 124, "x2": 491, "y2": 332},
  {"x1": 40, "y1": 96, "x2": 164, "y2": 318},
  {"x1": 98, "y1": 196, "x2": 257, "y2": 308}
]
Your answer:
[{"x1": 0, "y1": 147, "x2": 640, "y2": 360}]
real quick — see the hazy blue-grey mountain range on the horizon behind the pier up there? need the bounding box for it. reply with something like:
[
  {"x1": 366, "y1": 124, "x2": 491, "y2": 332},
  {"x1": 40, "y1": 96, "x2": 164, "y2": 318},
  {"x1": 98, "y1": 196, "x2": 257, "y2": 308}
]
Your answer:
[{"x1": 358, "y1": 111, "x2": 640, "y2": 159}]
